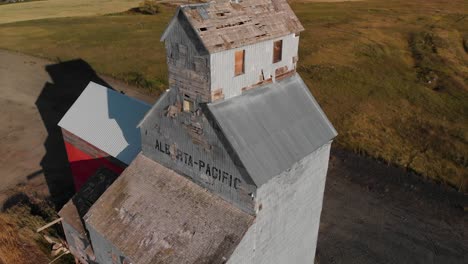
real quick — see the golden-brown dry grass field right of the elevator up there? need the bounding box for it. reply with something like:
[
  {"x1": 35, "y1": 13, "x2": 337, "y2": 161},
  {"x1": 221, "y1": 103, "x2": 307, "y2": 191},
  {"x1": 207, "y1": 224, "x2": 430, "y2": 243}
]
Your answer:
[{"x1": 294, "y1": 1, "x2": 468, "y2": 191}]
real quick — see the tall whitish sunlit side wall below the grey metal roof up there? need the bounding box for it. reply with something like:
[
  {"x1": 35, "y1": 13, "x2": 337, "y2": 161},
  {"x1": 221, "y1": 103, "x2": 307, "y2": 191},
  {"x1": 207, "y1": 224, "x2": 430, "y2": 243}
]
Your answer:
[{"x1": 227, "y1": 142, "x2": 331, "y2": 264}]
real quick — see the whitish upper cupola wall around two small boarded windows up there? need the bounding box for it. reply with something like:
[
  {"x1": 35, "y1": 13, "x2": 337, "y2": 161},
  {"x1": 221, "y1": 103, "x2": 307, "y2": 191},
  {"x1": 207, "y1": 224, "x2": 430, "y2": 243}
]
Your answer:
[{"x1": 210, "y1": 34, "x2": 299, "y2": 99}]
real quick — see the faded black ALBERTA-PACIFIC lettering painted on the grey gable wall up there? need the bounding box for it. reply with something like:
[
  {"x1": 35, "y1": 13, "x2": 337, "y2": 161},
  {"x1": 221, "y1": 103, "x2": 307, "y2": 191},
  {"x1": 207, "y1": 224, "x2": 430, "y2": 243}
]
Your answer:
[{"x1": 154, "y1": 139, "x2": 242, "y2": 190}]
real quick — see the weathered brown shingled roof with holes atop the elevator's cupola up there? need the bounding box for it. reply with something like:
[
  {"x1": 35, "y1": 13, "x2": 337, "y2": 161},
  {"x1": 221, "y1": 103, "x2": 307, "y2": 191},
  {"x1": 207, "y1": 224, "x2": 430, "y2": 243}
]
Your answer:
[{"x1": 161, "y1": 0, "x2": 304, "y2": 53}]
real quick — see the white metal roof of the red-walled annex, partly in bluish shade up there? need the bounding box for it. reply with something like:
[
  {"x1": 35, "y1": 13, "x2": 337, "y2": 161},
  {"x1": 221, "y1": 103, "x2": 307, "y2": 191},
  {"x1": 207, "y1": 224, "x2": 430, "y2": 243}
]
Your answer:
[{"x1": 58, "y1": 82, "x2": 151, "y2": 164}]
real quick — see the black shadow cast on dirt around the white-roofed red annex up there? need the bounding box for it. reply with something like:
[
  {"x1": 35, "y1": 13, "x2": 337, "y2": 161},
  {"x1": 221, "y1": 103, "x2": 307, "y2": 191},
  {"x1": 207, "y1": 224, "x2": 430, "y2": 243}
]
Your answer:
[{"x1": 36, "y1": 59, "x2": 110, "y2": 208}]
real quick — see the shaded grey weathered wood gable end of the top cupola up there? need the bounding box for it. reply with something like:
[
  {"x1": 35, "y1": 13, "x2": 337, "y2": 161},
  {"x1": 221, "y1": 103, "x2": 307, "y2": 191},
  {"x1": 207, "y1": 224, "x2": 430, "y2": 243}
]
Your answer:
[{"x1": 165, "y1": 17, "x2": 210, "y2": 102}]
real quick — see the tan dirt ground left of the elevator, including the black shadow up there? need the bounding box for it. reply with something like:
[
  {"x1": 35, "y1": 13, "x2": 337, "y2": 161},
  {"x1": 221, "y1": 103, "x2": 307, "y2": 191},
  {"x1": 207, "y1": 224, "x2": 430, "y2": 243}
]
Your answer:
[{"x1": 0, "y1": 50, "x2": 155, "y2": 206}]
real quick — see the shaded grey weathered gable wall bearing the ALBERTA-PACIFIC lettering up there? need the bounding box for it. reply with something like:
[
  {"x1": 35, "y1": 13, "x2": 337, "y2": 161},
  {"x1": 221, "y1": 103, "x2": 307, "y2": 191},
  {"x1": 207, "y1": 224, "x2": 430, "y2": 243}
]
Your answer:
[{"x1": 140, "y1": 88, "x2": 256, "y2": 213}]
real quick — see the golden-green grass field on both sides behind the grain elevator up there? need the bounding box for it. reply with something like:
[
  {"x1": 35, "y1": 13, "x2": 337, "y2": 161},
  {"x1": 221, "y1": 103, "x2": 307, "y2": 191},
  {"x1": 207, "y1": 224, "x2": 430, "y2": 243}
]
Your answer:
[{"x1": 0, "y1": 0, "x2": 468, "y2": 191}]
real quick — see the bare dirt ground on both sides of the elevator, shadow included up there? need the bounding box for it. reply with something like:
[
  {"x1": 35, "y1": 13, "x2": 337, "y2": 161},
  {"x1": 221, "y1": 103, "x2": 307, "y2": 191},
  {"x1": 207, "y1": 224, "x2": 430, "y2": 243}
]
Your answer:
[{"x1": 0, "y1": 50, "x2": 468, "y2": 264}]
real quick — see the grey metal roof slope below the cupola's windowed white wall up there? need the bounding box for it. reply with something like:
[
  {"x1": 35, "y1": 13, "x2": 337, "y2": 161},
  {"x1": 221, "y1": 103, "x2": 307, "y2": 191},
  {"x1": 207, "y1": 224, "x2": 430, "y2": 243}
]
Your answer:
[{"x1": 208, "y1": 74, "x2": 337, "y2": 186}]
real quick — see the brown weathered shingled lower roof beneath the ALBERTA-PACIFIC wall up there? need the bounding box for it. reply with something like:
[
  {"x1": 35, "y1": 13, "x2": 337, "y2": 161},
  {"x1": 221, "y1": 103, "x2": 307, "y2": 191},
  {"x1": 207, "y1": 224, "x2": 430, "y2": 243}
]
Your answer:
[{"x1": 85, "y1": 154, "x2": 253, "y2": 264}]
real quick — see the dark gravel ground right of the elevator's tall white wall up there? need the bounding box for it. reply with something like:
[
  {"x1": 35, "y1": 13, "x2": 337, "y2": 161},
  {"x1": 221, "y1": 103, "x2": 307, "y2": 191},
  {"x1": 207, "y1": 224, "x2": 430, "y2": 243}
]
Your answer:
[{"x1": 317, "y1": 147, "x2": 468, "y2": 264}]
